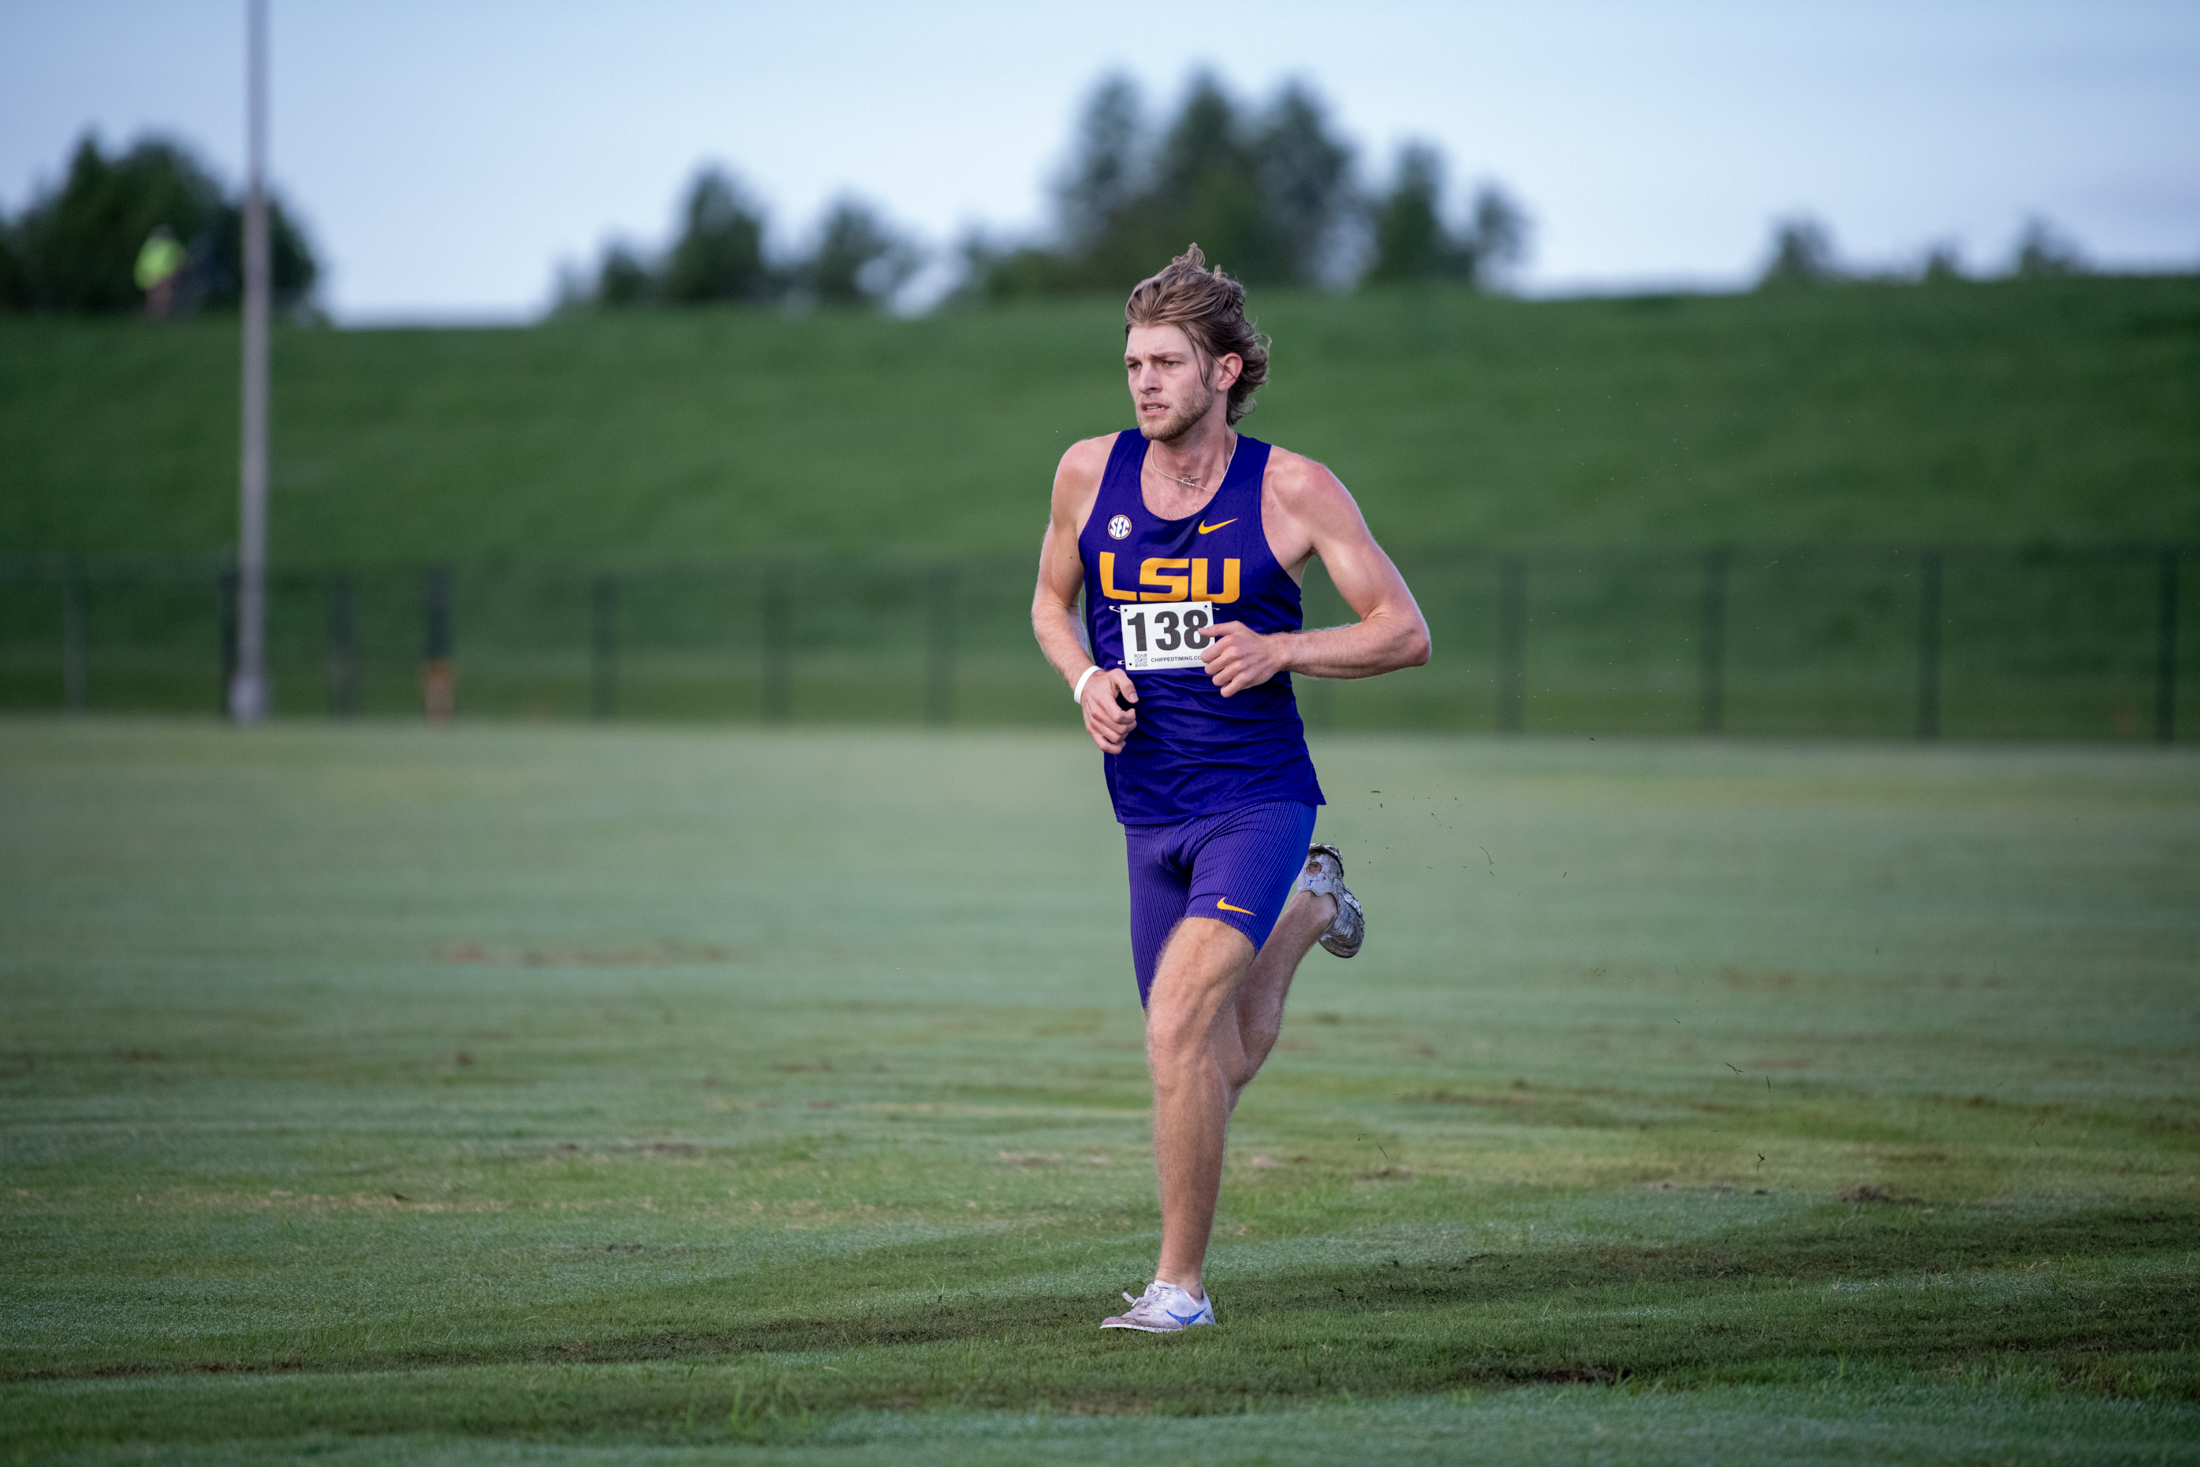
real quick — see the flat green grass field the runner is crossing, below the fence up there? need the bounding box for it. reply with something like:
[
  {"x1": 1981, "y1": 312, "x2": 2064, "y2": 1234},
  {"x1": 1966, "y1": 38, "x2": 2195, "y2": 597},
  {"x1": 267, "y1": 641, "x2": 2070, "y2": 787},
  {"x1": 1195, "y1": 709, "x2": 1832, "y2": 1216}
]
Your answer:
[{"x1": 0, "y1": 721, "x2": 2200, "y2": 1463}]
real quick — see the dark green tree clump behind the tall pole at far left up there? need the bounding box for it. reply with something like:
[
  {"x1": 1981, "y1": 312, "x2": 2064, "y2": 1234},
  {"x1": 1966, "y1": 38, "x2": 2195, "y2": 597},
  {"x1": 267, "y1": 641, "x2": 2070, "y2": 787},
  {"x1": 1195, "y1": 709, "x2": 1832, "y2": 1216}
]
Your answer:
[{"x1": 0, "y1": 134, "x2": 321, "y2": 315}]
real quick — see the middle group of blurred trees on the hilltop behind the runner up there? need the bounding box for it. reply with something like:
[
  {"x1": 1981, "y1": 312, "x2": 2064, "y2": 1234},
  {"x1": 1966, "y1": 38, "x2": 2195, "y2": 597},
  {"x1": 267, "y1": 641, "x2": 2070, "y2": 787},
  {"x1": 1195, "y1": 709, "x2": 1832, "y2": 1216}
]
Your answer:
[{"x1": 559, "y1": 75, "x2": 1529, "y2": 310}]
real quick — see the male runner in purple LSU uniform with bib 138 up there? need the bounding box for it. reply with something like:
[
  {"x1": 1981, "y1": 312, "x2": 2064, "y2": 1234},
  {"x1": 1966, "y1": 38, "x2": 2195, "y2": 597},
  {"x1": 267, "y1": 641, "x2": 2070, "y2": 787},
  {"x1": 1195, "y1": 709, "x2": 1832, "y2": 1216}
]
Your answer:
[{"x1": 1032, "y1": 244, "x2": 1428, "y2": 1333}]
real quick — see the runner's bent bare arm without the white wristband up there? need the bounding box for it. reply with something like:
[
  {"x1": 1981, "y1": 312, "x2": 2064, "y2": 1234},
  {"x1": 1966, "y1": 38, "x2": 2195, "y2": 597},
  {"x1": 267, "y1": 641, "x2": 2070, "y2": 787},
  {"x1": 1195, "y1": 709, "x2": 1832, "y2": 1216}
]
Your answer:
[{"x1": 1206, "y1": 455, "x2": 1428, "y2": 697}]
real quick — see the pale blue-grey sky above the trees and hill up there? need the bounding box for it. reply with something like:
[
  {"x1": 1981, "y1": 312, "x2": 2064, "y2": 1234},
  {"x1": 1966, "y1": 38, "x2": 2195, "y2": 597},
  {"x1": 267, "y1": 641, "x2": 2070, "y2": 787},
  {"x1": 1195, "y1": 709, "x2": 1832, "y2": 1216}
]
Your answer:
[{"x1": 0, "y1": 0, "x2": 2200, "y2": 321}]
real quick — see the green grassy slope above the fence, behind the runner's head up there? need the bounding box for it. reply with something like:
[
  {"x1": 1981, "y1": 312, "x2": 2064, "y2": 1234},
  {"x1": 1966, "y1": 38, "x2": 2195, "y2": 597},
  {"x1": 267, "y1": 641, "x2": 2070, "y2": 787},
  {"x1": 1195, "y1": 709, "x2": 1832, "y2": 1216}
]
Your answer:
[{"x1": 0, "y1": 277, "x2": 2200, "y2": 563}]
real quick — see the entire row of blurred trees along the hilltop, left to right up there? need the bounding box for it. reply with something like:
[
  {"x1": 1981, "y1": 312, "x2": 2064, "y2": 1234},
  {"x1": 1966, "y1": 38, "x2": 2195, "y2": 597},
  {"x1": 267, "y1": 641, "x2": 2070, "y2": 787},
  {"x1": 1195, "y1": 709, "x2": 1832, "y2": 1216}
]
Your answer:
[{"x1": 0, "y1": 75, "x2": 2088, "y2": 315}]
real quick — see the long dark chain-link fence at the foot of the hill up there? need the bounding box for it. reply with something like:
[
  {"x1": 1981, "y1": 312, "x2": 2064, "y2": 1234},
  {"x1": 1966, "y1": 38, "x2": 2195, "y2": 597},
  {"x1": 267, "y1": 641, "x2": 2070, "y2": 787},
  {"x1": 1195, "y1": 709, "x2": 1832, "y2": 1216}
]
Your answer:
[{"x1": 0, "y1": 545, "x2": 2193, "y2": 741}]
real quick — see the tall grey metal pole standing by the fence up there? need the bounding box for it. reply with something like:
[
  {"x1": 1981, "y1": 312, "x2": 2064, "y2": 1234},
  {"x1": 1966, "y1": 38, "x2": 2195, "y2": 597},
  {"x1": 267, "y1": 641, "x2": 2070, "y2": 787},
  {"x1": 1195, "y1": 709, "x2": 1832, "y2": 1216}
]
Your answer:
[{"x1": 229, "y1": 0, "x2": 268, "y2": 724}]
